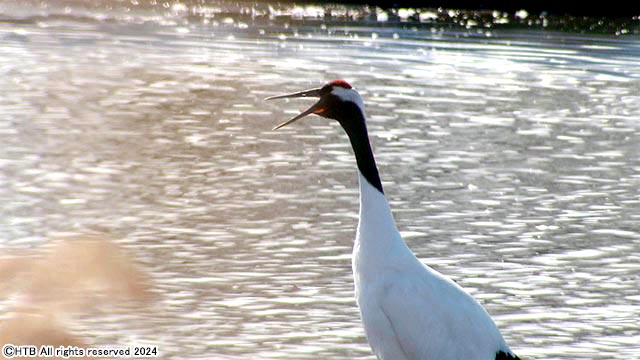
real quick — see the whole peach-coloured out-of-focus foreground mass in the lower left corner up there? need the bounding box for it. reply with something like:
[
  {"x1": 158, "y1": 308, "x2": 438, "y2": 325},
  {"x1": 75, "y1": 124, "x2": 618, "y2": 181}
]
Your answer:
[{"x1": 0, "y1": 235, "x2": 155, "y2": 358}]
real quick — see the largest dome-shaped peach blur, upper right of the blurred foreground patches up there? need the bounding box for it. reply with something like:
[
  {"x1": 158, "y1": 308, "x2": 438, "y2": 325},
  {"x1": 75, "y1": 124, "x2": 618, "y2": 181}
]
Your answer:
[{"x1": 25, "y1": 237, "x2": 152, "y2": 311}]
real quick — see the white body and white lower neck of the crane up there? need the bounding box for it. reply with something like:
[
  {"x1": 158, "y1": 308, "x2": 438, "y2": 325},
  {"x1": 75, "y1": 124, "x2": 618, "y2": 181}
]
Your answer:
[{"x1": 353, "y1": 173, "x2": 509, "y2": 360}]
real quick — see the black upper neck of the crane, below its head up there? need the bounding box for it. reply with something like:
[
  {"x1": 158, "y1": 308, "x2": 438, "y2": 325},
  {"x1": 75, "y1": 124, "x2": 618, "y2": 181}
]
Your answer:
[{"x1": 338, "y1": 104, "x2": 384, "y2": 194}]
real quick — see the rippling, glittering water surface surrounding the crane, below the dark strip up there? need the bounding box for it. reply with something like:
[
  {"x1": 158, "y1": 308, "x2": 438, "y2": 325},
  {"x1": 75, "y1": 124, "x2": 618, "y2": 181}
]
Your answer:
[{"x1": 0, "y1": 2, "x2": 640, "y2": 359}]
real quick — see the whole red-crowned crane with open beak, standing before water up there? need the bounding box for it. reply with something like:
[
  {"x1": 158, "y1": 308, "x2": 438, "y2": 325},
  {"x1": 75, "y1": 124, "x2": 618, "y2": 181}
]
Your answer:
[{"x1": 266, "y1": 80, "x2": 518, "y2": 360}]
